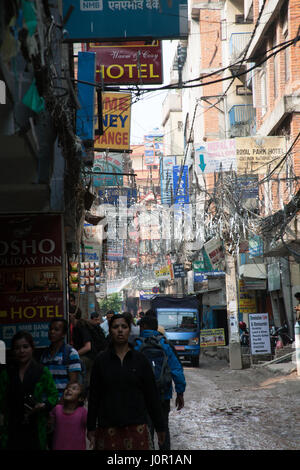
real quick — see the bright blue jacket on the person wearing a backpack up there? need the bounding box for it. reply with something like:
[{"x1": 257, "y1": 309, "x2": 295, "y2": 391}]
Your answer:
[{"x1": 134, "y1": 330, "x2": 186, "y2": 400}]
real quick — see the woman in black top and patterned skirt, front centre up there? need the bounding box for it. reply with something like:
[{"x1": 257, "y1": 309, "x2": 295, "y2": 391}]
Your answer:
[{"x1": 87, "y1": 314, "x2": 164, "y2": 451}]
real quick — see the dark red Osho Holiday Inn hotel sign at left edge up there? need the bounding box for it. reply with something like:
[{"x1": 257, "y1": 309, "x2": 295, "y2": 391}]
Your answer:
[{"x1": 0, "y1": 214, "x2": 64, "y2": 347}]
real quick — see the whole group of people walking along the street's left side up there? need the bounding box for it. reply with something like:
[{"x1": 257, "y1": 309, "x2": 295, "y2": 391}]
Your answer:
[{"x1": 0, "y1": 299, "x2": 186, "y2": 450}]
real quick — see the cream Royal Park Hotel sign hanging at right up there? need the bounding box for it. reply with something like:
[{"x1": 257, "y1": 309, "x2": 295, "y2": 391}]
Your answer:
[{"x1": 235, "y1": 136, "x2": 286, "y2": 175}]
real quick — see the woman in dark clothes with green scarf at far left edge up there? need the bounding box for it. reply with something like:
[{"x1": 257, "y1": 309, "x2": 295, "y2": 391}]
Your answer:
[{"x1": 0, "y1": 331, "x2": 58, "y2": 450}]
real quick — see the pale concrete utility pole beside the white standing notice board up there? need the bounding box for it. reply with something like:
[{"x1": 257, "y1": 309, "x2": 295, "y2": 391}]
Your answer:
[{"x1": 225, "y1": 248, "x2": 243, "y2": 370}]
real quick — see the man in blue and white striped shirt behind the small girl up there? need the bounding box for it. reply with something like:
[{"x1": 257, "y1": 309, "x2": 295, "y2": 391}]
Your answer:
[{"x1": 40, "y1": 318, "x2": 81, "y2": 399}]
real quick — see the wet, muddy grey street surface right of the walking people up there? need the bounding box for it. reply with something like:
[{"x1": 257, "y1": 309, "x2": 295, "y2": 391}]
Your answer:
[{"x1": 169, "y1": 355, "x2": 300, "y2": 450}]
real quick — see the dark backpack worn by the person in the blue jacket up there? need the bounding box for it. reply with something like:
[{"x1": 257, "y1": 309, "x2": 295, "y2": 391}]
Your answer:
[{"x1": 137, "y1": 336, "x2": 172, "y2": 400}]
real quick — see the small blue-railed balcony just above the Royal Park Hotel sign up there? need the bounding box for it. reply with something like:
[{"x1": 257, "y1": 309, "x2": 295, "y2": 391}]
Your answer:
[{"x1": 228, "y1": 104, "x2": 256, "y2": 137}]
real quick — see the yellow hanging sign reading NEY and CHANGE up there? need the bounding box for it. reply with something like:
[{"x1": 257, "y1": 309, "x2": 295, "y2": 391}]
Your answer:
[{"x1": 95, "y1": 92, "x2": 131, "y2": 152}]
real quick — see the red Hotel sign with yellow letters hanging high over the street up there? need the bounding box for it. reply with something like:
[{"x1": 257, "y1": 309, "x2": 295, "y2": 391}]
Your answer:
[{"x1": 87, "y1": 41, "x2": 163, "y2": 85}]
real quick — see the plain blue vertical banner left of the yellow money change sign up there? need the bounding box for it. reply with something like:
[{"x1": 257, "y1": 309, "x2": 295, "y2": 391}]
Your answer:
[{"x1": 76, "y1": 52, "x2": 96, "y2": 141}]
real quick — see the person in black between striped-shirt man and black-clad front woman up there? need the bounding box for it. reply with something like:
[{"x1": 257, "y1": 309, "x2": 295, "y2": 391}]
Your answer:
[{"x1": 69, "y1": 313, "x2": 93, "y2": 389}]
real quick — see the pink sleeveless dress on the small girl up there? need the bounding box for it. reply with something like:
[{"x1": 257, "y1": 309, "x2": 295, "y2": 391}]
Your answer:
[{"x1": 51, "y1": 405, "x2": 87, "y2": 450}]
